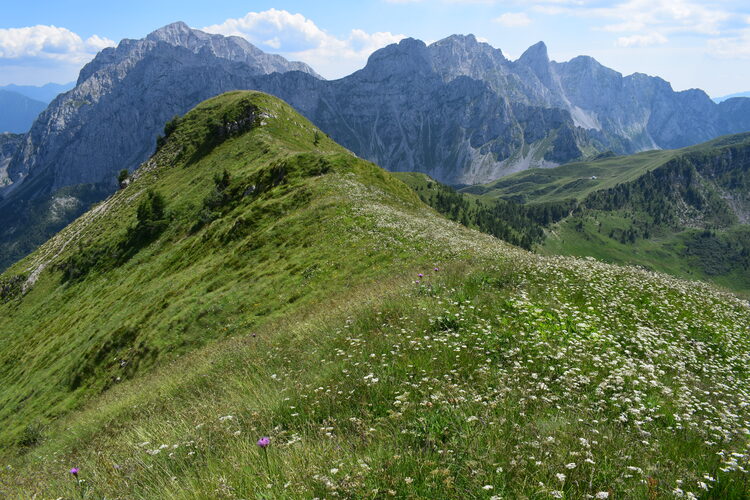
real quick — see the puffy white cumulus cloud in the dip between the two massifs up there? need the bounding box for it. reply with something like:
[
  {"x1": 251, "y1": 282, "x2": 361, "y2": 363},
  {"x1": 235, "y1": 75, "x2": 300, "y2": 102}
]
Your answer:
[{"x1": 202, "y1": 9, "x2": 405, "y2": 78}]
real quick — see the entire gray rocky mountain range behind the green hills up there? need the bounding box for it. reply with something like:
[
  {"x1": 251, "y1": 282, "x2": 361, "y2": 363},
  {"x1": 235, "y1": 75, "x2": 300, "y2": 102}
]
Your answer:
[{"x1": 0, "y1": 23, "x2": 750, "y2": 274}]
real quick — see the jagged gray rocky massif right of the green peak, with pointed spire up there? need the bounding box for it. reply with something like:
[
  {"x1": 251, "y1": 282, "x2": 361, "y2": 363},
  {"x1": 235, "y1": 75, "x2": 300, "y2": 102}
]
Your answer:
[{"x1": 264, "y1": 35, "x2": 750, "y2": 184}]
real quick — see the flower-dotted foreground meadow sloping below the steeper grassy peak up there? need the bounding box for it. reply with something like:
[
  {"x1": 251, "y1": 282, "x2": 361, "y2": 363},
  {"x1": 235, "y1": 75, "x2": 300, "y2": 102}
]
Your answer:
[{"x1": 5, "y1": 247, "x2": 750, "y2": 498}]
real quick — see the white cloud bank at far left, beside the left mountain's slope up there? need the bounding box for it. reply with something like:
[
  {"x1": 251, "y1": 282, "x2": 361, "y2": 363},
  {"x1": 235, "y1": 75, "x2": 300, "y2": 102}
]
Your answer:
[{"x1": 0, "y1": 25, "x2": 115, "y2": 64}]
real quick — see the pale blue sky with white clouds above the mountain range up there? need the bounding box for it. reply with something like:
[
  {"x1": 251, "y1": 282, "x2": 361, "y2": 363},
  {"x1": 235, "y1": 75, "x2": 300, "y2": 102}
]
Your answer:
[{"x1": 0, "y1": 0, "x2": 750, "y2": 97}]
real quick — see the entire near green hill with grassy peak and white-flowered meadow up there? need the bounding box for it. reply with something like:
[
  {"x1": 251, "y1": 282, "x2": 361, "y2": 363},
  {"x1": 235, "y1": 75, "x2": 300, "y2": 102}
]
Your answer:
[{"x1": 0, "y1": 92, "x2": 750, "y2": 499}]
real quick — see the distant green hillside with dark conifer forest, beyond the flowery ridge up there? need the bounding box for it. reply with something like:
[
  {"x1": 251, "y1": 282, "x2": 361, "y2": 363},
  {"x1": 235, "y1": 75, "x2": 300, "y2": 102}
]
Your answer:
[{"x1": 406, "y1": 134, "x2": 750, "y2": 296}]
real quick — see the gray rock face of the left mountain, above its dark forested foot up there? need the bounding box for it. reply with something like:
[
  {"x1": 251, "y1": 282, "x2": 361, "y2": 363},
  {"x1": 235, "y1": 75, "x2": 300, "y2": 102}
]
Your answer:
[{"x1": 2, "y1": 23, "x2": 317, "y2": 195}]
